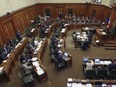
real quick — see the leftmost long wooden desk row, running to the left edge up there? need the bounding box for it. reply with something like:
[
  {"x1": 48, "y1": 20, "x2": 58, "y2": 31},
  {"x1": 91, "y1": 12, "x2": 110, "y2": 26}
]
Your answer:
[{"x1": 0, "y1": 37, "x2": 28, "y2": 81}]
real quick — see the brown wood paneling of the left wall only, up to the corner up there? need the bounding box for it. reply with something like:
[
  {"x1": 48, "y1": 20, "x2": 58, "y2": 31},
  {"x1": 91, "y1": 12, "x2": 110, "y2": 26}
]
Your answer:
[{"x1": 0, "y1": 4, "x2": 38, "y2": 46}]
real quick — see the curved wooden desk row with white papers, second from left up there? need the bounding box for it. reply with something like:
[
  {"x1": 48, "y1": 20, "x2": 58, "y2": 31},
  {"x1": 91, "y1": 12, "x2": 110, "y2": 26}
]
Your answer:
[{"x1": 32, "y1": 38, "x2": 48, "y2": 81}]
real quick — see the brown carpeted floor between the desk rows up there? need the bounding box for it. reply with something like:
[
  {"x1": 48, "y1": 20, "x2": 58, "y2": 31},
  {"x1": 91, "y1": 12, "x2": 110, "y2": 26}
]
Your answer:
[{"x1": 0, "y1": 30, "x2": 116, "y2": 87}]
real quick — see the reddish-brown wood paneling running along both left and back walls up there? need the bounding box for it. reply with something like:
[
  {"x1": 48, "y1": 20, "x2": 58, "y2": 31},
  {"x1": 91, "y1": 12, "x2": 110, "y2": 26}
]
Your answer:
[{"x1": 0, "y1": 3, "x2": 116, "y2": 45}]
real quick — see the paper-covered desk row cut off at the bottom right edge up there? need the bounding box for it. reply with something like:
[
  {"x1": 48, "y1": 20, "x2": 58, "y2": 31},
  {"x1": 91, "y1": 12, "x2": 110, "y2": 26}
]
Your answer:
[{"x1": 67, "y1": 78, "x2": 116, "y2": 87}]
